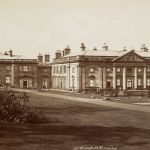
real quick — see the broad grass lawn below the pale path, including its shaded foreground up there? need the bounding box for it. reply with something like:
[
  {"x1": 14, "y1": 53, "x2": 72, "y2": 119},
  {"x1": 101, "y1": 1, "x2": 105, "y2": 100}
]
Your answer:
[{"x1": 0, "y1": 95, "x2": 150, "y2": 150}]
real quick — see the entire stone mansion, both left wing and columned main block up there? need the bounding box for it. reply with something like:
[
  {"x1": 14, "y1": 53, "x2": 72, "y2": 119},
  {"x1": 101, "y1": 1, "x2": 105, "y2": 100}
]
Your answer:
[{"x1": 0, "y1": 43, "x2": 150, "y2": 91}]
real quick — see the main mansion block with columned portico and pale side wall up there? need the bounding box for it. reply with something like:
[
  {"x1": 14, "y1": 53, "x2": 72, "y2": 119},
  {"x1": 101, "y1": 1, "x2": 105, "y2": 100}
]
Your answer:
[{"x1": 52, "y1": 43, "x2": 150, "y2": 91}]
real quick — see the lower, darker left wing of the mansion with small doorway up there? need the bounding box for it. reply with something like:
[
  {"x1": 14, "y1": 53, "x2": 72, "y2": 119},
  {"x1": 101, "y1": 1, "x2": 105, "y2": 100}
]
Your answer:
[{"x1": 0, "y1": 51, "x2": 50, "y2": 89}]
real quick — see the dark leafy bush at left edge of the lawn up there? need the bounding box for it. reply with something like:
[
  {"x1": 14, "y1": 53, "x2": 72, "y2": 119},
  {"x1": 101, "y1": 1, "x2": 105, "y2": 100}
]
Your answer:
[{"x1": 0, "y1": 89, "x2": 47, "y2": 124}]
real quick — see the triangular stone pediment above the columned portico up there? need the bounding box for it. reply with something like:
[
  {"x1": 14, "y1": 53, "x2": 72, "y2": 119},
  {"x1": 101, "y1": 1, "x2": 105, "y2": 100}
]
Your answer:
[{"x1": 114, "y1": 51, "x2": 144, "y2": 62}]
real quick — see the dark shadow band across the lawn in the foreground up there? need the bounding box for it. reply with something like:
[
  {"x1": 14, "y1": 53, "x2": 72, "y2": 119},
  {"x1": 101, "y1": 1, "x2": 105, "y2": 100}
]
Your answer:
[{"x1": 0, "y1": 124, "x2": 150, "y2": 146}]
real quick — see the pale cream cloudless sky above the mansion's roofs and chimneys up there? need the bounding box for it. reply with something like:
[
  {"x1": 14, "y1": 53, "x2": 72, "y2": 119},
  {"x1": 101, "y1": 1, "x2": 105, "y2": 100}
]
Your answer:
[{"x1": 0, "y1": 0, "x2": 150, "y2": 57}]
